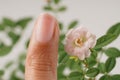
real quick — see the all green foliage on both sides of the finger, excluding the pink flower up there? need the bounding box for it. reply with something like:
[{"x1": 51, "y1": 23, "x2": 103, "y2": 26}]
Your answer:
[{"x1": 0, "y1": 0, "x2": 120, "y2": 80}]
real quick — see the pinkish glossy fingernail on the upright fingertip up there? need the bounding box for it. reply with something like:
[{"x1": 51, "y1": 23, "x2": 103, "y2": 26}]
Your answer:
[{"x1": 36, "y1": 13, "x2": 55, "y2": 43}]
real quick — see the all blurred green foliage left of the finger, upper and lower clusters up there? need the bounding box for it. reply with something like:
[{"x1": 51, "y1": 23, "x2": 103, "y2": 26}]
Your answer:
[{"x1": 0, "y1": 17, "x2": 32, "y2": 80}]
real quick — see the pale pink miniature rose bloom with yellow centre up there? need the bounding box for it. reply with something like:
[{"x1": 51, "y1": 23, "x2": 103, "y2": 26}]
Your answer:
[{"x1": 65, "y1": 27, "x2": 96, "y2": 60}]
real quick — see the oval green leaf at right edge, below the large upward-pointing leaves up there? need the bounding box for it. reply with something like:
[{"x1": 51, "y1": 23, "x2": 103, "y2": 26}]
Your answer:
[{"x1": 105, "y1": 47, "x2": 120, "y2": 58}]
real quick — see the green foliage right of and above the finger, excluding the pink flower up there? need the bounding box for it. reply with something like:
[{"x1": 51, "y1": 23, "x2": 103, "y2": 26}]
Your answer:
[{"x1": 43, "y1": 0, "x2": 120, "y2": 80}]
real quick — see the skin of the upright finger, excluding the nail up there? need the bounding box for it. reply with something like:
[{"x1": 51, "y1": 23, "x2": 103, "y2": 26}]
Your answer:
[{"x1": 25, "y1": 14, "x2": 59, "y2": 80}]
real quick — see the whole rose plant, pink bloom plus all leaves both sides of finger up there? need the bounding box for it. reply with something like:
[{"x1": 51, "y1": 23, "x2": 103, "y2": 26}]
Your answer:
[{"x1": 0, "y1": 0, "x2": 120, "y2": 80}]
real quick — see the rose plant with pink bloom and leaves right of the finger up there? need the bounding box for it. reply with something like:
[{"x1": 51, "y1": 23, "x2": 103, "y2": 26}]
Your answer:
[{"x1": 44, "y1": 0, "x2": 120, "y2": 80}]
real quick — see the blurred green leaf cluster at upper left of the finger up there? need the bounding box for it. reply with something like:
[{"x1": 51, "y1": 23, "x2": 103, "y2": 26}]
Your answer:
[{"x1": 0, "y1": 17, "x2": 32, "y2": 56}]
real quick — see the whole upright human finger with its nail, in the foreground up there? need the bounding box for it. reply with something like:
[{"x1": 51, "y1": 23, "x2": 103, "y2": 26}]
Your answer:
[{"x1": 25, "y1": 13, "x2": 59, "y2": 80}]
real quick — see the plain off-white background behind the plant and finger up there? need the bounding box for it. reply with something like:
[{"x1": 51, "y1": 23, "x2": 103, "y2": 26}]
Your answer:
[{"x1": 0, "y1": 0, "x2": 120, "y2": 79}]
